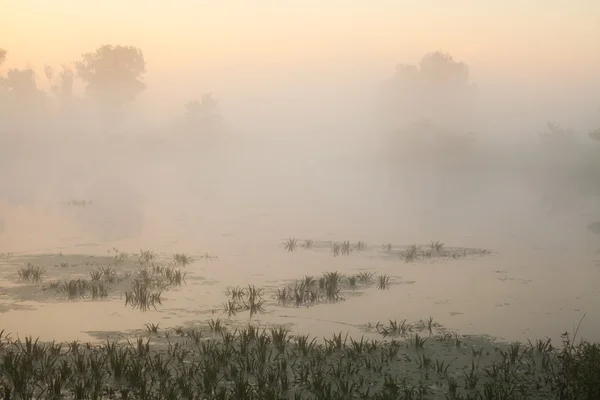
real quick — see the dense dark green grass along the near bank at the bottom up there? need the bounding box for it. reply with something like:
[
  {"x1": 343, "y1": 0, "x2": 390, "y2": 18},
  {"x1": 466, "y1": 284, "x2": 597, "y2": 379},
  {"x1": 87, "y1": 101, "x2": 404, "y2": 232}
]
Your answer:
[{"x1": 0, "y1": 320, "x2": 600, "y2": 400}]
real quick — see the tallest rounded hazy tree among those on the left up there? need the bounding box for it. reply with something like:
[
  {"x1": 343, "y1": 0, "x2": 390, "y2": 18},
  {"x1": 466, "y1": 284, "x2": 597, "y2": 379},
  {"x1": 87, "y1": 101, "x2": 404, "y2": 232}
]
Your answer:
[{"x1": 75, "y1": 45, "x2": 146, "y2": 124}]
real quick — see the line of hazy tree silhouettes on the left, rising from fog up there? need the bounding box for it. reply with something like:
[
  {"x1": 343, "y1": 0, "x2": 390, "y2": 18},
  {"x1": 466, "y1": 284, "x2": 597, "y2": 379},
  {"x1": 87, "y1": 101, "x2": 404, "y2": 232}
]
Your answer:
[{"x1": 0, "y1": 45, "x2": 220, "y2": 132}]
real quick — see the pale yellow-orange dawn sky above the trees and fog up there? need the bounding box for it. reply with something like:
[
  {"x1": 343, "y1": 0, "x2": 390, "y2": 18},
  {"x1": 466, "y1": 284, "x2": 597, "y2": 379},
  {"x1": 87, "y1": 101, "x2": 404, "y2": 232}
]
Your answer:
[{"x1": 0, "y1": 0, "x2": 600, "y2": 125}]
